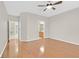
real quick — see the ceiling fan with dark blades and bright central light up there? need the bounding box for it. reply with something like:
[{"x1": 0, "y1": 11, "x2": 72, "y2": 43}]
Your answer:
[{"x1": 38, "y1": 1, "x2": 62, "y2": 11}]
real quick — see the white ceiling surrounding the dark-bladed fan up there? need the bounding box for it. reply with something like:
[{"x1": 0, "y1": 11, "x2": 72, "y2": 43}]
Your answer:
[{"x1": 4, "y1": 1, "x2": 79, "y2": 17}]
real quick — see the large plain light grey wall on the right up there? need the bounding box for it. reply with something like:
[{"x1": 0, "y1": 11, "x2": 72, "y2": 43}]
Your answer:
[{"x1": 49, "y1": 8, "x2": 79, "y2": 44}]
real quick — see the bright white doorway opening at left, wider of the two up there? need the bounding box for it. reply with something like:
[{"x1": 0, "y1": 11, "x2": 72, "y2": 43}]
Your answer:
[{"x1": 9, "y1": 20, "x2": 19, "y2": 40}]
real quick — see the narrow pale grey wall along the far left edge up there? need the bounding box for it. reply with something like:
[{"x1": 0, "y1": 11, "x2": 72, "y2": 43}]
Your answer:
[{"x1": 0, "y1": 1, "x2": 7, "y2": 57}]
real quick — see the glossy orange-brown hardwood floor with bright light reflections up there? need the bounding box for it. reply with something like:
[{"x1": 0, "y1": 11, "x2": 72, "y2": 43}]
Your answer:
[{"x1": 2, "y1": 39, "x2": 79, "y2": 58}]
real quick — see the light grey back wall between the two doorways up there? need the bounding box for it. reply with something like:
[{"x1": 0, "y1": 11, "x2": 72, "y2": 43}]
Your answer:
[{"x1": 20, "y1": 13, "x2": 48, "y2": 41}]
